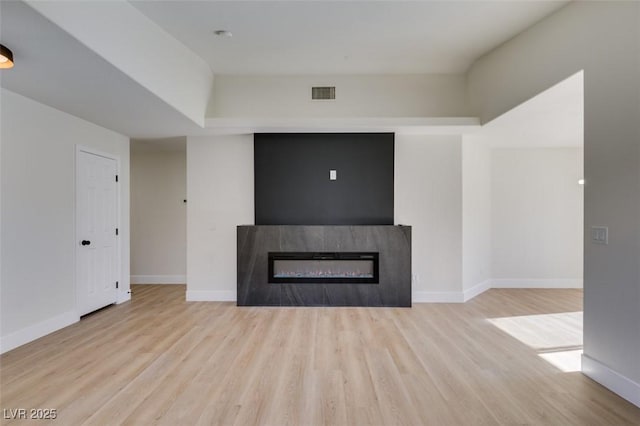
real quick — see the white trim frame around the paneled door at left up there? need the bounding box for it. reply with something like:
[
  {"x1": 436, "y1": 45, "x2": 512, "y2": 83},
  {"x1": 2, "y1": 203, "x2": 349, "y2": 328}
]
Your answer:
[{"x1": 73, "y1": 144, "x2": 121, "y2": 316}]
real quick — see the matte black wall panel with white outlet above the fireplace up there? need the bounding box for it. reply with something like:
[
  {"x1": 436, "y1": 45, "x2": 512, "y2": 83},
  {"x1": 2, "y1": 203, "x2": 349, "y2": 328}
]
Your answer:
[{"x1": 254, "y1": 133, "x2": 394, "y2": 225}]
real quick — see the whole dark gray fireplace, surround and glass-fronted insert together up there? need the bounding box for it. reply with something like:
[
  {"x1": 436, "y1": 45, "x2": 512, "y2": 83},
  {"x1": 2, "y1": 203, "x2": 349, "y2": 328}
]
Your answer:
[{"x1": 236, "y1": 225, "x2": 411, "y2": 307}]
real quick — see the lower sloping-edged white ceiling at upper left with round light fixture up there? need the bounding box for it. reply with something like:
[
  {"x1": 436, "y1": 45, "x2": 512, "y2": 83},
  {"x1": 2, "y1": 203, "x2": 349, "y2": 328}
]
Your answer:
[{"x1": 0, "y1": 0, "x2": 200, "y2": 138}]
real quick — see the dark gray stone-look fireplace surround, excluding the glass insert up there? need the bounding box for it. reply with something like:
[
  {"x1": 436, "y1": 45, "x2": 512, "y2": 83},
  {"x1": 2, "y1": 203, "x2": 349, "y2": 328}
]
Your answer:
[{"x1": 237, "y1": 226, "x2": 411, "y2": 307}]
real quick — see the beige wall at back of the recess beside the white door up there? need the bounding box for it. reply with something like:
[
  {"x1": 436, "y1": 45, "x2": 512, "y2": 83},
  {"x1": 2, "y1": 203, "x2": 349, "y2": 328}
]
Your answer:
[{"x1": 131, "y1": 142, "x2": 187, "y2": 284}]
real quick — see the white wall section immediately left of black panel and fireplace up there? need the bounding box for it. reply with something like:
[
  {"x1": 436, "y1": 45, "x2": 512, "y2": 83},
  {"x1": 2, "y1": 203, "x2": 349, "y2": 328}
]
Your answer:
[{"x1": 187, "y1": 135, "x2": 254, "y2": 301}]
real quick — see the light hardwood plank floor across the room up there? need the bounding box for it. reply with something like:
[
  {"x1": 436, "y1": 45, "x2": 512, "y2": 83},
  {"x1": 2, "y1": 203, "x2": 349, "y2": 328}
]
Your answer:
[{"x1": 0, "y1": 285, "x2": 640, "y2": 426}]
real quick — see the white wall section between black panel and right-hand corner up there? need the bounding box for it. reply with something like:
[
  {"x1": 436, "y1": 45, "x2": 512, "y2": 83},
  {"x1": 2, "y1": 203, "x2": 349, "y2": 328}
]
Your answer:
[{"x1": 394, "y1": 135, "x2": 462, "y2": 302}]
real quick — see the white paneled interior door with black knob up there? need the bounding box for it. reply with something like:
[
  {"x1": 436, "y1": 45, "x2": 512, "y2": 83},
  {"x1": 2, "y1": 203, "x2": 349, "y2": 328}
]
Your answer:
[{"x1": 76, "y1": 150, "x2": 119, "y2": 315}]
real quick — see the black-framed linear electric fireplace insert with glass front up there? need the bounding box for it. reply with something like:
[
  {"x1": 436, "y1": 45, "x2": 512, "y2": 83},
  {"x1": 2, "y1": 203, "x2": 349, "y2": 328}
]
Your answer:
[{"x1": 269, "y1": 252, "x2": 379, "y2": 284}]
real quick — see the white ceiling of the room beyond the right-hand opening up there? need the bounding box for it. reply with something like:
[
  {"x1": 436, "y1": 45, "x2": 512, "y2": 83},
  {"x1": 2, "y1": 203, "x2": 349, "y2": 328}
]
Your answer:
[{"x1": 479, "y1": 72, "x2": 584, "y2": 148}]
